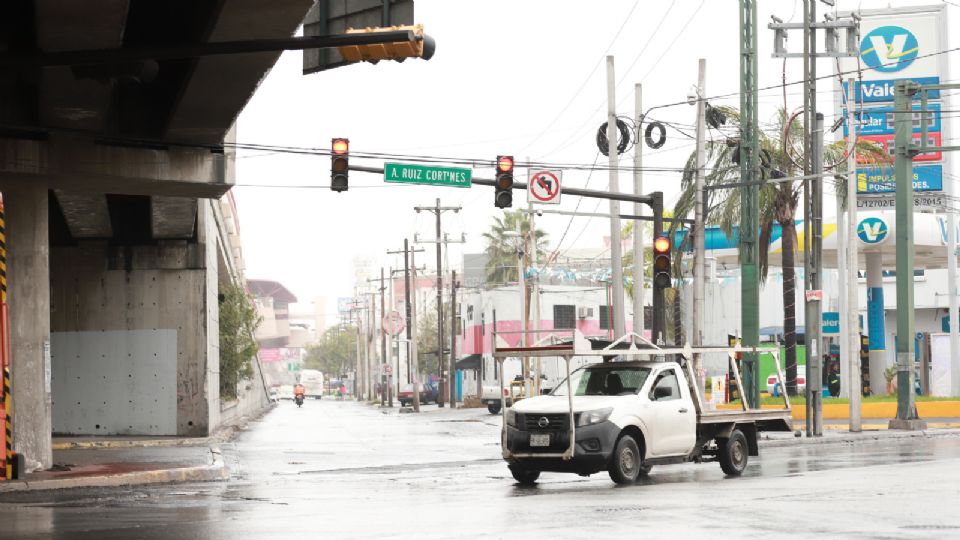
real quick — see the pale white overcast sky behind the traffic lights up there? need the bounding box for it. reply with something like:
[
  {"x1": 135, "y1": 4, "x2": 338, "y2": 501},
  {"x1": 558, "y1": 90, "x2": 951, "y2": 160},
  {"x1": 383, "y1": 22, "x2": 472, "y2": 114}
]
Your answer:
[{"x1": 233, "y1": 0, "x2": 960, "y2": 324}]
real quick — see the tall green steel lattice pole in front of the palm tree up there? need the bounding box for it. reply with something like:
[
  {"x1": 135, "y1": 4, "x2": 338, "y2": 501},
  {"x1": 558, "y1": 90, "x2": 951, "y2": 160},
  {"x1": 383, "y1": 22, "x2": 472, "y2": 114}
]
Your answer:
[{"x1": 740, "y1": 0, "x2": 766, "y2": 408}]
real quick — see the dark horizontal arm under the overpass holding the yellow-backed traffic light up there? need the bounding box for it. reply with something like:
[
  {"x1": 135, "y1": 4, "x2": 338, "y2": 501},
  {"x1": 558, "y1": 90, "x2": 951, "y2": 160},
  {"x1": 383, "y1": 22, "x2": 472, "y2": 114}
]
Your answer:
[{"x1": 0, "y1": 30, "x2": 423, "y2": 67}]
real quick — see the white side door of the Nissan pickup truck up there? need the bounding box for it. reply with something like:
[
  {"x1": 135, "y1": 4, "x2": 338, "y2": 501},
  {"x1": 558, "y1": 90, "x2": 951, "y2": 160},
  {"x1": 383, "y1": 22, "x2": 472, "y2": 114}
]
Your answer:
[{"x1": 647, "y1": 367, "x2": 697, "y2": 456}]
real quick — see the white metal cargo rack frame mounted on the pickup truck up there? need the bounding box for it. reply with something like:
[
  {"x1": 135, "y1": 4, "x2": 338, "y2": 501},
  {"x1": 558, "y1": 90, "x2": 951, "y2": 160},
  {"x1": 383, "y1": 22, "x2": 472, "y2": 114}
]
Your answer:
[{"x1": 493, "y1": 330, "x2": 791, "y2": 461}]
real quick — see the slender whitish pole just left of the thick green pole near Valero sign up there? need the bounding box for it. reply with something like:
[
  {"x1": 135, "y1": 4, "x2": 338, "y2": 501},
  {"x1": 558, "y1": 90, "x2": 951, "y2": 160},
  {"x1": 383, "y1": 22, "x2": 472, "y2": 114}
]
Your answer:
[{"x1": 840, "y1": 77, "x2": 863, "y2": 433}]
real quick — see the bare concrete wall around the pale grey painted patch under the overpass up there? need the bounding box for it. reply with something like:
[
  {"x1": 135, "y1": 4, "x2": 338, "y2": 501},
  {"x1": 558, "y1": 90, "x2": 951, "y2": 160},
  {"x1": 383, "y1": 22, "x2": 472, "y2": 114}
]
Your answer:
[{"x1": 50, "y1": 242, "x2": 212, "y2": 436}]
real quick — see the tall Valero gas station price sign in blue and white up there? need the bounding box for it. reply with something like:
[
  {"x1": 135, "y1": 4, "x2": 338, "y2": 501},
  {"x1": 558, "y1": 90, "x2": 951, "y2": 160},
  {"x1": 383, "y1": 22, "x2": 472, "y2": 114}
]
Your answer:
[{"x1": 836, "y1": 4, "x2": 950, "y2": 195}]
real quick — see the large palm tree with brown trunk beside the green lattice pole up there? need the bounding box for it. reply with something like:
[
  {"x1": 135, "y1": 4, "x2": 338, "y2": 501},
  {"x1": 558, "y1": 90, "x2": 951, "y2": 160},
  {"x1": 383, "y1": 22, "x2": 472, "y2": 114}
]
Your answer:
[{"x1": 670, "y1": 107, "x2": 890, "y2": 395}]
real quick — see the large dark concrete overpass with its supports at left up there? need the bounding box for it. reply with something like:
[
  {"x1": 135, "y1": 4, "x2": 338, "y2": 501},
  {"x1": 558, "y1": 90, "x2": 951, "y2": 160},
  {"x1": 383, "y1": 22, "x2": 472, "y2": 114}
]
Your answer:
[{"x1": 0, "y1": 0, "x2": 312, "y2": 467}]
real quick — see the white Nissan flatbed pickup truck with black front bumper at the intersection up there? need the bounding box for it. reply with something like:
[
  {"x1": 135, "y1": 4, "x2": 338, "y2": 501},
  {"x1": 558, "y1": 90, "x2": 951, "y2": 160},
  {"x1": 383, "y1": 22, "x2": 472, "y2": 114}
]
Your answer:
[{"x1": 495, "y1": 338, "x2": 791, "y2": 484}]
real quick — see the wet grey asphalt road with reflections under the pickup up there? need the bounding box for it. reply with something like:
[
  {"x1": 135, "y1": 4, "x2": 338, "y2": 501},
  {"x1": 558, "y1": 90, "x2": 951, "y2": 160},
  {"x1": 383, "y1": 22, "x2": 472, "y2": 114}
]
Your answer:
[{"x1": 0, "y1": 400, "x2": 960, "y2": 540}]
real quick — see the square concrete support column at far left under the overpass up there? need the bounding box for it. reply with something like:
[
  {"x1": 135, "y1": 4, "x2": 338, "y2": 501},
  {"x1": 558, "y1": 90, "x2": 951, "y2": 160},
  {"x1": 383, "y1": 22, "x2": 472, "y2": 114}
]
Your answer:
[{"x1": 3, "y1": 185, "x2": 53, "y2": 468}]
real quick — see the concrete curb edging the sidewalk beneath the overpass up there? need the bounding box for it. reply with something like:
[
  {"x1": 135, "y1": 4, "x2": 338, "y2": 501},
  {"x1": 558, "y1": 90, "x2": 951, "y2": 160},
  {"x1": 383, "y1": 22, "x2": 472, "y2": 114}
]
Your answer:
[{"x1": 0, "y1": 446, "x2": 230, "y2": 494}]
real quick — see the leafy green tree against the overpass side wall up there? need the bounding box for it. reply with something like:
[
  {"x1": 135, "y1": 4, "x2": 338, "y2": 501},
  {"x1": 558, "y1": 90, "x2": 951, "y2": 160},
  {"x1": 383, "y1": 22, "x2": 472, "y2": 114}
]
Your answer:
[{"x1": 219, "y1": 283, "x2": 262, "y2": 400}]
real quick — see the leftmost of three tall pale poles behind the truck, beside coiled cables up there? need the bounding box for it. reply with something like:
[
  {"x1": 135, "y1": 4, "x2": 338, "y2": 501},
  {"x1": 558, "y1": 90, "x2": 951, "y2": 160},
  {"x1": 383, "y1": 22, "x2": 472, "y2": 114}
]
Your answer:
[{"x1": 607, "y1": 56, "x2": 627, "y2": 337}]
